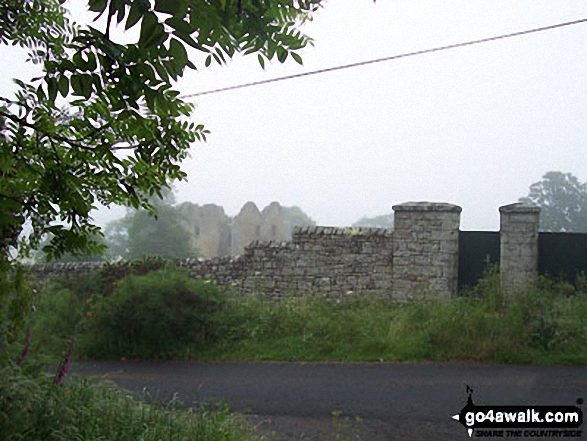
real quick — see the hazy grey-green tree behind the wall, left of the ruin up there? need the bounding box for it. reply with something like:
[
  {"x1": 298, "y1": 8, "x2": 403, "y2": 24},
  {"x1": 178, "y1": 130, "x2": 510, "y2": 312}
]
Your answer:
[{"x1": 106, "y1": 192, "x2": 197, "y2": 259}]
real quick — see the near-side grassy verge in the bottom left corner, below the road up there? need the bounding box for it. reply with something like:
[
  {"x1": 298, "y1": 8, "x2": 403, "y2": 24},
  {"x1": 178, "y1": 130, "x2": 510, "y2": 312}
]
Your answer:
[{"x1": 0, "y1": 360, "x2": 262, "y2": 441}]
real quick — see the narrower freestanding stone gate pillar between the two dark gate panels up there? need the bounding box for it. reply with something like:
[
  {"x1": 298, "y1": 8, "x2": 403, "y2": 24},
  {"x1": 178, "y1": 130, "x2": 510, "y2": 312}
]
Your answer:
[{"x1": 499, "y1": 203, "x2": 540, "y2": 295}]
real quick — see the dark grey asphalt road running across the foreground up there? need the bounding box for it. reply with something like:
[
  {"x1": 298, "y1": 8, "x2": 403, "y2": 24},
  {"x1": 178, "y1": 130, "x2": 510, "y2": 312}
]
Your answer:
[{"x1": 71, "y1": 361, "x2": 587, "y2": 441}]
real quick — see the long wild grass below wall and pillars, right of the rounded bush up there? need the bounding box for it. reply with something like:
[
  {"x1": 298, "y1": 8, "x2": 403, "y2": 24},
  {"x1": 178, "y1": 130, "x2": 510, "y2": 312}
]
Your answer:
[{"x1": 193, "y1": 281, "x2": 587, "y2": 364}]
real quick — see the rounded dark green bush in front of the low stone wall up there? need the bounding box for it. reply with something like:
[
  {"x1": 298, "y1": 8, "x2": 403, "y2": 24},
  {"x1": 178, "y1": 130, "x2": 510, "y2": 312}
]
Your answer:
[{"x1": 81, "y1": 264, "x2": 224, "y2": 358}]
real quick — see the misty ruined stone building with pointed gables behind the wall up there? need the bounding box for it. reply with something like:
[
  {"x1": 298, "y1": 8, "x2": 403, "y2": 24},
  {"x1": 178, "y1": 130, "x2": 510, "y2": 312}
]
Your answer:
[{"x1": 180, "y1": 202, "x2": 294, "y2": 259}]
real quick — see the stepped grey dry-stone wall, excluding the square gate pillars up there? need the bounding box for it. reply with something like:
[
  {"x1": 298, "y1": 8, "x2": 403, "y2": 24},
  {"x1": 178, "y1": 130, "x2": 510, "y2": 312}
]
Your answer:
[{"x1": 28, "y1": 227, "x2": 393, "y2": 299}]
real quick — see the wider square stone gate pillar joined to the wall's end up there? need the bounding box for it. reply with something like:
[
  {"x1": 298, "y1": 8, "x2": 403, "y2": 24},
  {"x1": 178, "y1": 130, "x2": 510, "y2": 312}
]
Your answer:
[{"x1": 392, "y1": 202, "x2": 461, "y2": 300}]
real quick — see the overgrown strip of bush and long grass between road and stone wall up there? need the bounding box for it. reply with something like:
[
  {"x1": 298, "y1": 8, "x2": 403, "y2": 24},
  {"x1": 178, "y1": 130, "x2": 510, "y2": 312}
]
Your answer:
[{"x1": 25, "y1": 266, "x2": 587, "y2": 363}]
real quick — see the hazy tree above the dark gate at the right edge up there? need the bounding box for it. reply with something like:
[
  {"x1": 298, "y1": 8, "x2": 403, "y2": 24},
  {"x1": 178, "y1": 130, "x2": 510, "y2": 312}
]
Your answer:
[{"x1": 519, "y1": 171, "x2": 587, "y2": 233}]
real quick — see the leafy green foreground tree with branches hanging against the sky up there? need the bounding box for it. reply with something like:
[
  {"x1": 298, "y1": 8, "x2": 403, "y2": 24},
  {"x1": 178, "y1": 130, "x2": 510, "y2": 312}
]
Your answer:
[{"x1": 0, "y1": 0, "x2": 322, "y2": 261}]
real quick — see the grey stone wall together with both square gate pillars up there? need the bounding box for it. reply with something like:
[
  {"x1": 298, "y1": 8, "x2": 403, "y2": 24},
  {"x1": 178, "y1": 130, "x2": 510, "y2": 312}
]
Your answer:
[{"x1": 27, "y1": 202, "x2": 539, "y2": 300}]
